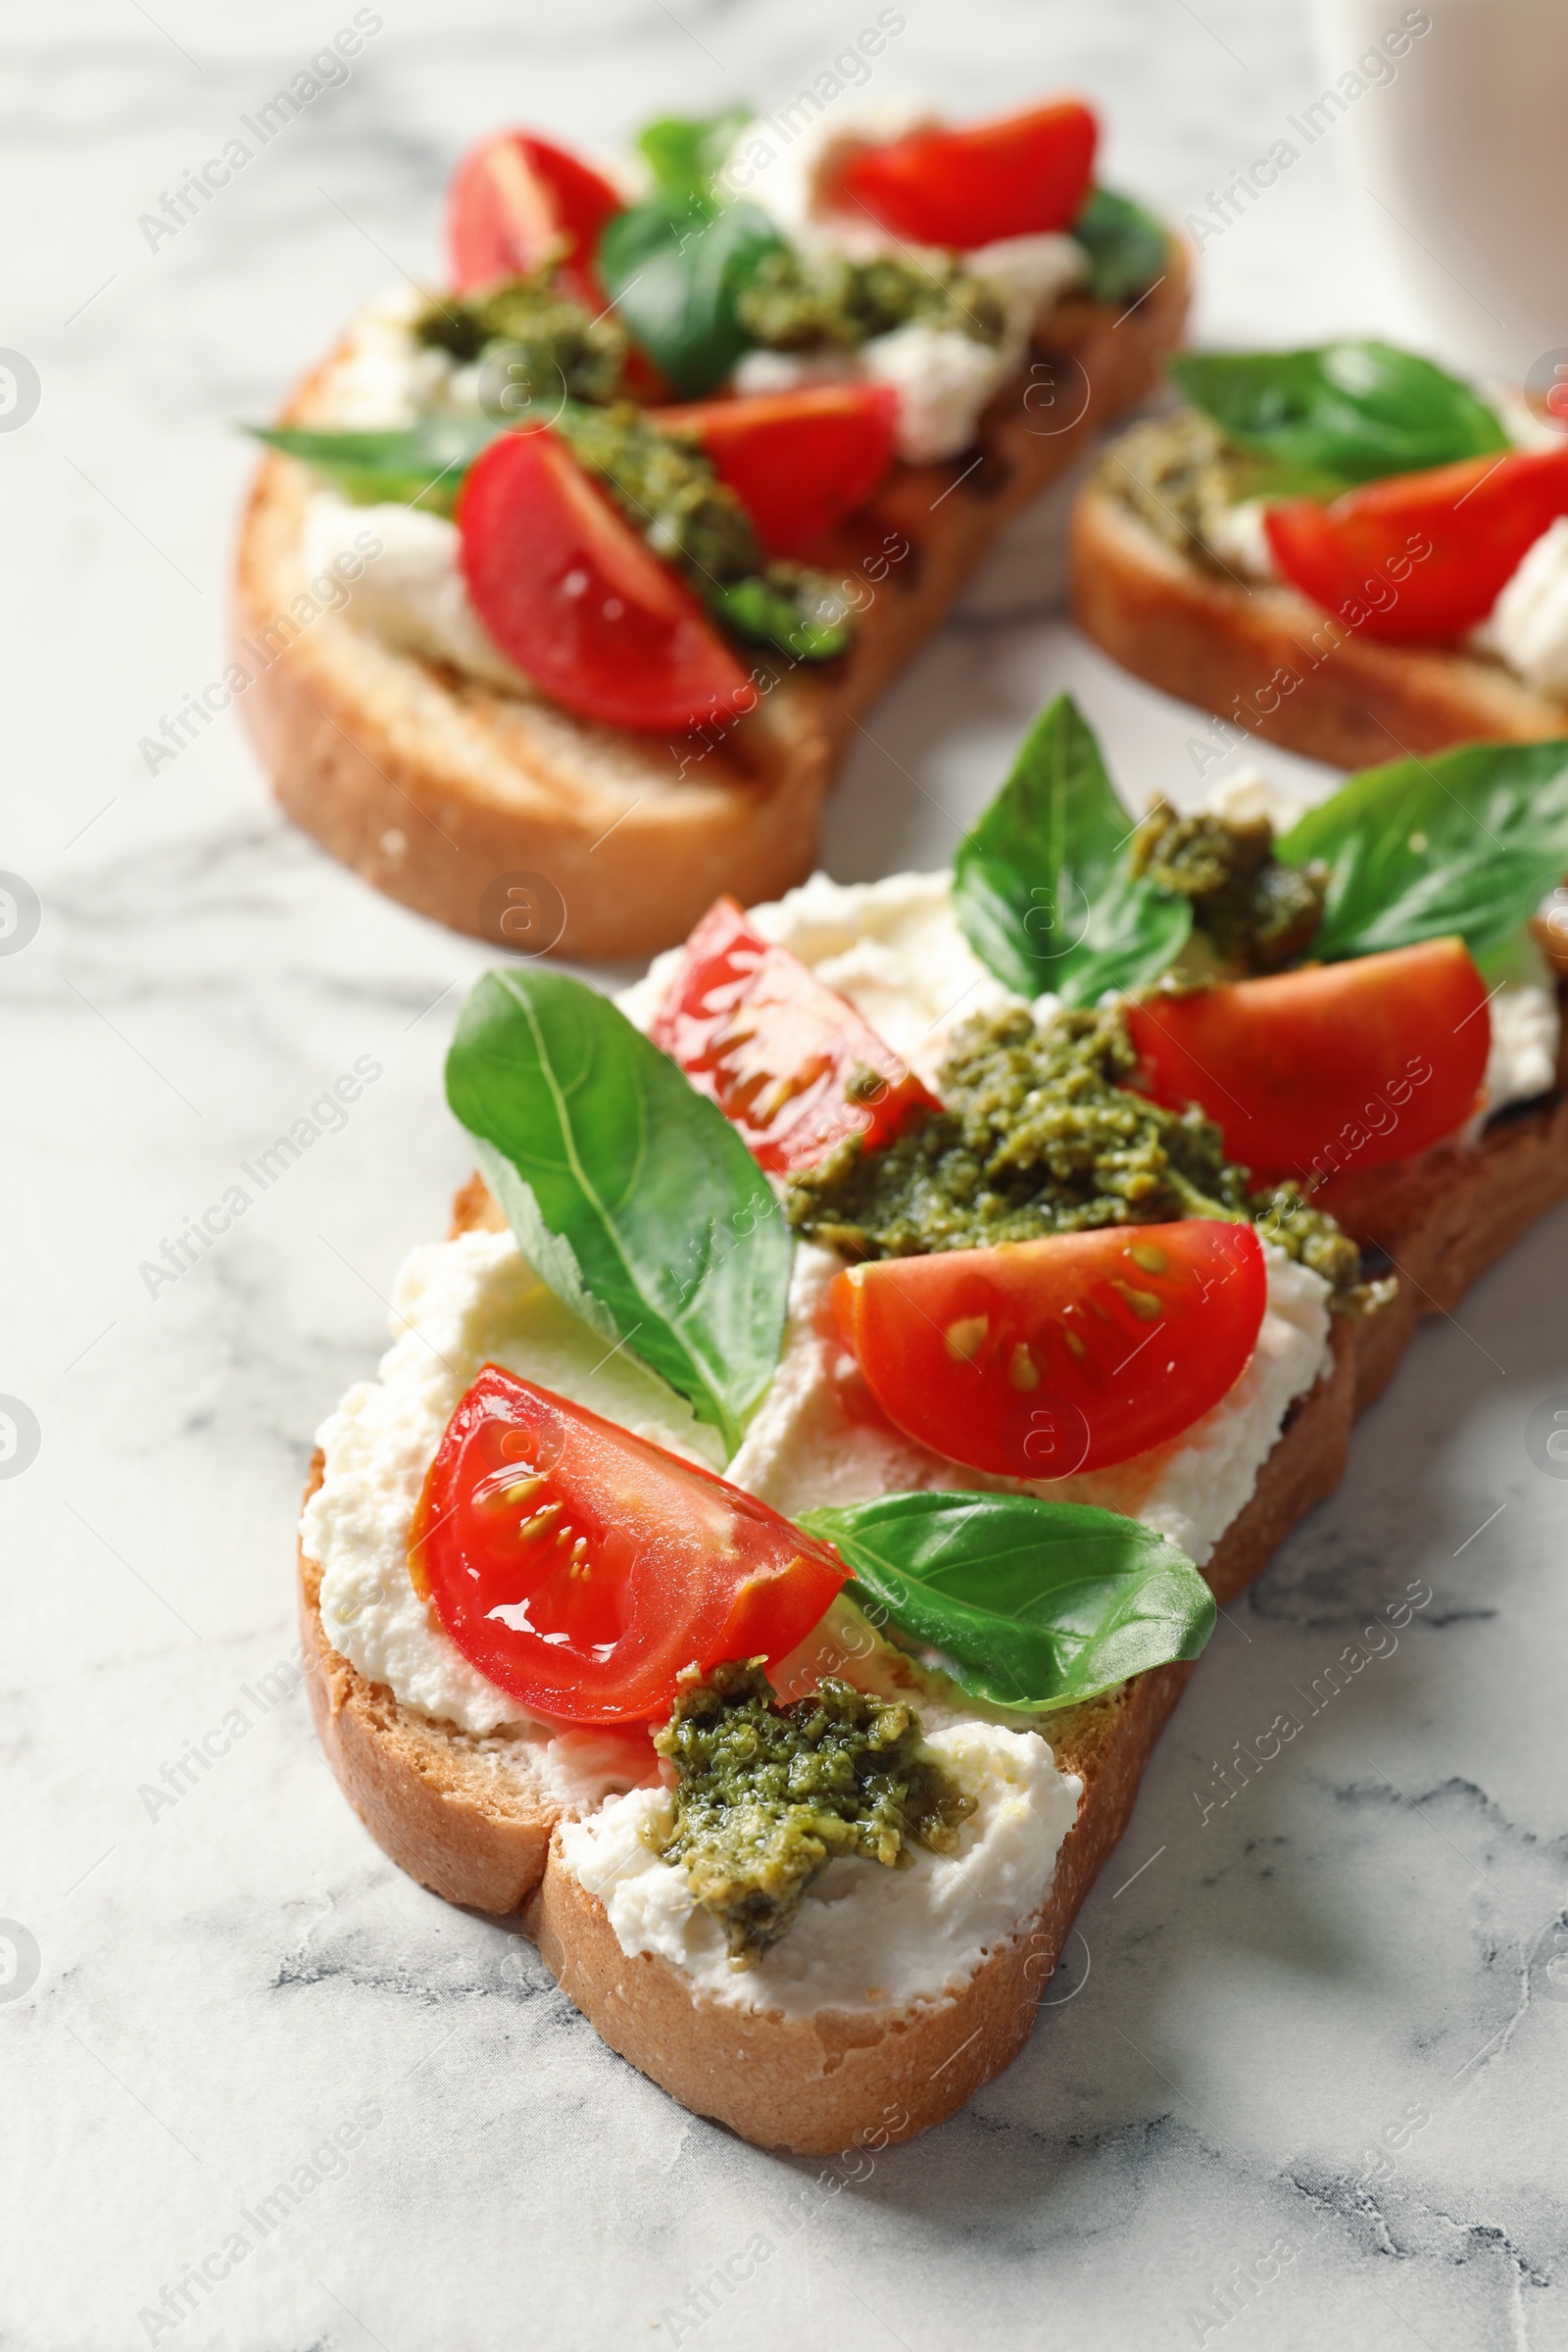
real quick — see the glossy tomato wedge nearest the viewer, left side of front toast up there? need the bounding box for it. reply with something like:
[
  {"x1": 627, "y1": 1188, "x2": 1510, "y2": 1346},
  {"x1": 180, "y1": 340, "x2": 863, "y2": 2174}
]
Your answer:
[{"x1": 409, "y1": 1364, "x2": 847, "y2": 1724}]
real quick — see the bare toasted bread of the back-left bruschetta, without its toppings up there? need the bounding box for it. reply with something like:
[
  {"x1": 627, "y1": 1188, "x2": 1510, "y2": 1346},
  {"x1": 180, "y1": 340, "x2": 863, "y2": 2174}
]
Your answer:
[{"x1": 235, "y1": 242, "x2": 1187, "y2": 955}]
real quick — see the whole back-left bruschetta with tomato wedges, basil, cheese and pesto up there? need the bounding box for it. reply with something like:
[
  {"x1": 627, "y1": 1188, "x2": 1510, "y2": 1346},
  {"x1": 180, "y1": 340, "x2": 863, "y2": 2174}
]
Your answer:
[{"x1": 230, "y1": 101, "x2": 1187, "y2": 955}]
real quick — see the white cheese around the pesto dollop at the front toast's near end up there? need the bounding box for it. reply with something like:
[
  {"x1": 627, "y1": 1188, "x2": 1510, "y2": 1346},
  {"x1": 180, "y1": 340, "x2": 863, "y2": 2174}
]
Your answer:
[{"x1": 562, "y1": 1722, "x2": 1084, "y2": 2016}]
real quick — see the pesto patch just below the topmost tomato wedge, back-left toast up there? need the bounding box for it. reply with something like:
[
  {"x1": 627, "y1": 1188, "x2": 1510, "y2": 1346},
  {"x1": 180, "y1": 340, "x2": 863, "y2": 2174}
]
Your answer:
[{"x1": 736, "y1": 249, "x2": 1006, "y2": 351}]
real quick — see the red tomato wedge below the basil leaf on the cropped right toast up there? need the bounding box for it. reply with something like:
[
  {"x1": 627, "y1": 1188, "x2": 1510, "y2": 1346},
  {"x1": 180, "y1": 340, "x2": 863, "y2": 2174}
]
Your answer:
[{"x1": 1265, "y1": 447, "x2": 1568, "y2": 645}]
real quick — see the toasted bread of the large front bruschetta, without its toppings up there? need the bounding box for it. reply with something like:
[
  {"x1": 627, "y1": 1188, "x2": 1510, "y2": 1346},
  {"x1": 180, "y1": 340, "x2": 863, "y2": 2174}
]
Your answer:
[{"x1": 299, "y1": 1011, "x2": 1568, "y2": 2154}]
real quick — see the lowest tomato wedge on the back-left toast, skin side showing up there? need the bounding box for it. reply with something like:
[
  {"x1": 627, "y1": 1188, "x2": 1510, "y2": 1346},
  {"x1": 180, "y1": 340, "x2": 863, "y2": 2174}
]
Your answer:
[{"x1": 459, "y1": 433, "x2": 755, "y2": 727}]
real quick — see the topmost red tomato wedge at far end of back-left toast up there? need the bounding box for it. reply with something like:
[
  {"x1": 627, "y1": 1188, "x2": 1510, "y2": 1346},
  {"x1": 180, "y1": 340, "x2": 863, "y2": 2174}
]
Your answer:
[{"x1": 835, "y1": 99, "x2": 1098, "y2": 252}]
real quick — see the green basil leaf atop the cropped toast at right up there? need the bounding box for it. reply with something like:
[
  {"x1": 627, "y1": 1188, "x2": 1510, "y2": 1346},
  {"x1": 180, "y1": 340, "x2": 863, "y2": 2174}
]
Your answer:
[{"x1": 1168, "y1": 341, "x2": 1509, "y2": 484}]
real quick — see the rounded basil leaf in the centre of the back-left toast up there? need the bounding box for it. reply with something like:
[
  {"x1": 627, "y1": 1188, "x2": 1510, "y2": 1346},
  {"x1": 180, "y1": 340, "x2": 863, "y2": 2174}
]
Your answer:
[{"x1": 597, "y1": 190, "x2": 783, "y2": 400}]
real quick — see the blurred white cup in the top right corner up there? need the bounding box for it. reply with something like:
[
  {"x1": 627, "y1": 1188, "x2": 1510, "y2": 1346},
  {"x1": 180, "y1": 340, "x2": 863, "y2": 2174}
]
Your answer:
[{"x1": 1316, "y1": 0, "x2": 1568, "y2": 381}]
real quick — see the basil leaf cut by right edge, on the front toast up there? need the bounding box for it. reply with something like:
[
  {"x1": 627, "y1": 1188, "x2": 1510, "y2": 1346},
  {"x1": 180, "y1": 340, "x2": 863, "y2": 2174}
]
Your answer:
[{"x1": 1279, "y1": 739, "x2": 1568, "y2": 962}]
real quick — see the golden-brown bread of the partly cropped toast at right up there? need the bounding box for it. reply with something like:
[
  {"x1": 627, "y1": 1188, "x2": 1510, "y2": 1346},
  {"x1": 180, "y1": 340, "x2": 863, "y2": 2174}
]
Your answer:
[{"x1": 1067, "y1": 482, "x2": 1568, "y2": 769}]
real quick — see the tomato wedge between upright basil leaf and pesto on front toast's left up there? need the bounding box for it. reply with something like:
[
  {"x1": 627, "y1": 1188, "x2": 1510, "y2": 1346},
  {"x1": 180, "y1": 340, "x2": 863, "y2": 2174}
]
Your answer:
[{"x1": 649, "y1": 899, "x2": 938, "y2": 1176}]
